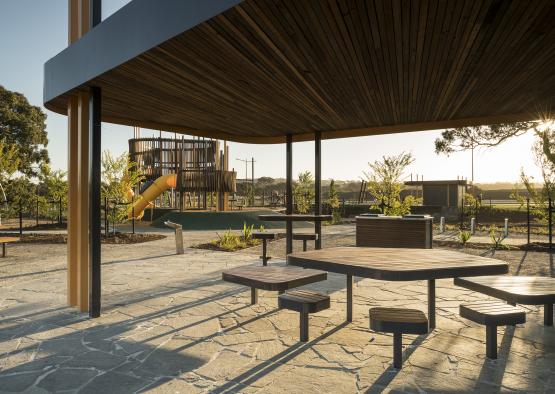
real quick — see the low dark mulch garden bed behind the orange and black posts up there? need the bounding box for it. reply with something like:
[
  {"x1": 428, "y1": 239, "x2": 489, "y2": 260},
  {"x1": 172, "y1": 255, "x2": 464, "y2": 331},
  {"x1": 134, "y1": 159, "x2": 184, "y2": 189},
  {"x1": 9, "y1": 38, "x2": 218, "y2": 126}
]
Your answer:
[{"x1": 0, "y1": 233, "x2": 166, "y2": 245}]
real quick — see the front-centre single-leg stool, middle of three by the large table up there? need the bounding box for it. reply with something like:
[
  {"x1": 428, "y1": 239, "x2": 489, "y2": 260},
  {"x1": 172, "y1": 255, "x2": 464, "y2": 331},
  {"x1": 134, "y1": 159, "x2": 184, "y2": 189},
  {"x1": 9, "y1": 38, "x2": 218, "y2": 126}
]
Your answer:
[{"x1": 369, "y1": 308, "x2": 428, "y2": 369}]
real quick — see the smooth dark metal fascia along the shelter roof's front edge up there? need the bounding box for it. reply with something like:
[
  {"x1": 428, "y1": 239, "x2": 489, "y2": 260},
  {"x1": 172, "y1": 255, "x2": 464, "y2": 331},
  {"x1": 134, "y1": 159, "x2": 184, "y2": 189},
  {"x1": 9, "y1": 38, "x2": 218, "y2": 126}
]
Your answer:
[{"x1": 43, "y1": 0, "x2": 242, "y2": 104}]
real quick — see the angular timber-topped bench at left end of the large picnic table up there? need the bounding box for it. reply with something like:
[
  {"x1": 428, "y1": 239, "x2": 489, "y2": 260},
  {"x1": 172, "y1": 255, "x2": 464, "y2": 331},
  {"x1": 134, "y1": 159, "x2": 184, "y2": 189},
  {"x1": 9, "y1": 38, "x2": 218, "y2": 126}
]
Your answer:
[{"x1": 222, "y1": 265, "x2": 328, "y2": 305}]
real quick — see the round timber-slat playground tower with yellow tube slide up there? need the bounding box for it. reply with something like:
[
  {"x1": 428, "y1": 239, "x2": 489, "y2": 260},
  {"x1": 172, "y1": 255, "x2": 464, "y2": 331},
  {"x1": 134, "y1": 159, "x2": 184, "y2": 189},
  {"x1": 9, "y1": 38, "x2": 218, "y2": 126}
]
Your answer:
[{"x1": 129, "y1": 128, "x2": 236, "y2": 217}]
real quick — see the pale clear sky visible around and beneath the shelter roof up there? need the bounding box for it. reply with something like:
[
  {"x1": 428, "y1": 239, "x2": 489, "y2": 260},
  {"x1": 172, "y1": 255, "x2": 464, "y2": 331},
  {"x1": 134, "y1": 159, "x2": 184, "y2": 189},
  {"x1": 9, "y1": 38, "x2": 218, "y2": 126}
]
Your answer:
[{"x1": 0, "y1": 0, "x2": 540, "y2": 183}]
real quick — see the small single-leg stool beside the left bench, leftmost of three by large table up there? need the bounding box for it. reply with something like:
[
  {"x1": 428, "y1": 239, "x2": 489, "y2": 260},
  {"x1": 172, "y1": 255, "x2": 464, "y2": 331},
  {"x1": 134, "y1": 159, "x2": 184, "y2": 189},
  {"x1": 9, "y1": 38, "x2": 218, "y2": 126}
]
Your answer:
[{"x1": 278, "y1": 290, "x2": 330, "y2": 342}]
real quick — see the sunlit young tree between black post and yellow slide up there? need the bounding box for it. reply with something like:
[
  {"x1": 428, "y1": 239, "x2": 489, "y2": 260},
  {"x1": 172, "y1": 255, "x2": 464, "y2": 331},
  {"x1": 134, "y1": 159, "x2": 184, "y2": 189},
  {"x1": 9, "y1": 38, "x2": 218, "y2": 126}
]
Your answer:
[{"x1": 101, "y1": 151, "x2": 144, "y2": 221}]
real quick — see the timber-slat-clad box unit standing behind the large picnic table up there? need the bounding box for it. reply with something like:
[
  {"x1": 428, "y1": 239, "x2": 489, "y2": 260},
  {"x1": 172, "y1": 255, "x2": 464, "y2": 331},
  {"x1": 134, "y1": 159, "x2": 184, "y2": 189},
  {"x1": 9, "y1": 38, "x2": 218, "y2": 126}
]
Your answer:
[{"x1": 356, "y1": 216, "x2": 433, "y2": 249}]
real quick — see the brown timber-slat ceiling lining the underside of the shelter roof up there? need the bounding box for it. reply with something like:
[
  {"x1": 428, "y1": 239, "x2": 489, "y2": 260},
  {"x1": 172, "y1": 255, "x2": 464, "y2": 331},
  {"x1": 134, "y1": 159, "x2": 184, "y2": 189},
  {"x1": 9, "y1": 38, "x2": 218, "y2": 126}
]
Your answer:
[{"x1": 47, "y1": 0, "x2": 555, "y2": 142}]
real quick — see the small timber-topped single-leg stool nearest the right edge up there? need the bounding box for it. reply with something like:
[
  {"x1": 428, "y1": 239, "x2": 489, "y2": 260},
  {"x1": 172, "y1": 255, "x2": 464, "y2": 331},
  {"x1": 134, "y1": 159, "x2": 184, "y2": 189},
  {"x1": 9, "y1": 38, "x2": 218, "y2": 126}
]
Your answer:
[{"x1": 460, "y1": 301, "x2": 526, "y2": 359}]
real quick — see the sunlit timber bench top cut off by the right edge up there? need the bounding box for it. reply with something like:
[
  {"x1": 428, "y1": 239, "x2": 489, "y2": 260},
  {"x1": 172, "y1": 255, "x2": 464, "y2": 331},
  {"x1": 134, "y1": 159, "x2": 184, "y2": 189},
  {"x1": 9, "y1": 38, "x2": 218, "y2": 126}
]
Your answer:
[{"x1": 454, "y1": 275, "x2": 555, "y2": 305}]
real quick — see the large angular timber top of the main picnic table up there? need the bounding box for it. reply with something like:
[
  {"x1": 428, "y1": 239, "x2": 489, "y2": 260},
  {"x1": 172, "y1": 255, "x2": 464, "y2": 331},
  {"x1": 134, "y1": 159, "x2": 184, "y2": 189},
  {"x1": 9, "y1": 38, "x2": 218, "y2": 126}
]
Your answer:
[{"x1": 287, "y1": 247, "x2": 509, "y2": 281}]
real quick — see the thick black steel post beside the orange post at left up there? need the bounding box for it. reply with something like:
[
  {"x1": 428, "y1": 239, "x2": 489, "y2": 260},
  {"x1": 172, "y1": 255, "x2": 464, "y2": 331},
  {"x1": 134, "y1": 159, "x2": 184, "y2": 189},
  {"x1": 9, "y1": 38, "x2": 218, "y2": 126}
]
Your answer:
[{"x1": 89, "y1": 87, "x2": 102, "y2": 317}]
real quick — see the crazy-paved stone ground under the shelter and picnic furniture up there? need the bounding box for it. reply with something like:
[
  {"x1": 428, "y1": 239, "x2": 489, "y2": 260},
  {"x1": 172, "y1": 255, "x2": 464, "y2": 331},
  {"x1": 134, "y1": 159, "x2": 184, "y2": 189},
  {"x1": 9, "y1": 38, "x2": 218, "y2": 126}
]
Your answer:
[{"x1": 0, "y1": 226, "x2": 555, "y2": 394}]
